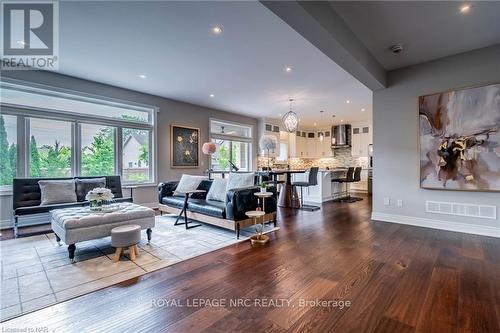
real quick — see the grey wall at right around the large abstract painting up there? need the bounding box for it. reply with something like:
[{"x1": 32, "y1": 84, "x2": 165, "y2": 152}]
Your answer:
[{"x1": 373, "y1": 45, "x2": 500, "y2": 236}]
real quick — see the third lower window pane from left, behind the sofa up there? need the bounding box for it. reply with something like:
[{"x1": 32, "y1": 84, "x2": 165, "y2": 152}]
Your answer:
[{"x1": 81, "y1": 124, "x2": 116, "y2": 176}]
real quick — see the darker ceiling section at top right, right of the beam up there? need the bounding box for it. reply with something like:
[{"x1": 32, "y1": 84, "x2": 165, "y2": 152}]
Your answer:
[{"x1": 330, "y1": 1, "x2": 500, "y2": 70}]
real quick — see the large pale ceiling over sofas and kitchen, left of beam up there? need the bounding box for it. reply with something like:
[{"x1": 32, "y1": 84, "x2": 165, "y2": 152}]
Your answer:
[{"x1": 59, "y1": 2, "x2": 372, "y2": 126}]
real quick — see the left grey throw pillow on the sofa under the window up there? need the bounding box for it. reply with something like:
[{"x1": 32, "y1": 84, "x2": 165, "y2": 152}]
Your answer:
[{"x1": 38, "y1": 179, "x2": 76, "y2": 206}]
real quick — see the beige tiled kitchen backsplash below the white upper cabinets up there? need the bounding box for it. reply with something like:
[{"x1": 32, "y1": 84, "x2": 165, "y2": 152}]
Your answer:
[{"x1": 257, "y1": 148, "x2": 368, "y2": 169}]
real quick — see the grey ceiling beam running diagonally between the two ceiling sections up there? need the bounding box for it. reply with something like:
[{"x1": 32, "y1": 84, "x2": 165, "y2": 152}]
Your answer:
[{"x1": 261, "y1": 1, "x2": 386, "y2": 90}]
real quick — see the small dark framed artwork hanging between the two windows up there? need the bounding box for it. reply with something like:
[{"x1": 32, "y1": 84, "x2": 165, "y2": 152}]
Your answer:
[{"x1": 170, "y1": 125, "x2": 200, "y2": 168}]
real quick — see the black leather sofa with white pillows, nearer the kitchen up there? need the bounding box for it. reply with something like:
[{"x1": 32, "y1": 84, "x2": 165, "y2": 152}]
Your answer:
[{"x1": 158, "y1": 180, "x2": 277, "y2": 238}]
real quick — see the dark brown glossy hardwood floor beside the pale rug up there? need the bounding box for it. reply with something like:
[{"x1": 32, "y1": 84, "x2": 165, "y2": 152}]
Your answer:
[{"x1": 2, "y1": 198, "x2": 500, "y2": 333}]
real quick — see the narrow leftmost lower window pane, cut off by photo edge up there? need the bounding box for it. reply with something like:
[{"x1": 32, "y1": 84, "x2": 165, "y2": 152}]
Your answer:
[{"x1": 0, "y1": 115, "x2": 17, "y2": 187}]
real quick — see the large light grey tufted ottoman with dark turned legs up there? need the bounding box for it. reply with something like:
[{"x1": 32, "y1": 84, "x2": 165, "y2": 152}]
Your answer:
[{"x1": 50, "y1": 202, "x2": 155, "y2": 262}]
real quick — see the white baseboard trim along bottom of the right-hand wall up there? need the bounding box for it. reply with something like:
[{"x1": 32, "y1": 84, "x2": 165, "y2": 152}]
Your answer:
[{"x1": 371, "y1": 212, "x2": 500, "y2": 238}]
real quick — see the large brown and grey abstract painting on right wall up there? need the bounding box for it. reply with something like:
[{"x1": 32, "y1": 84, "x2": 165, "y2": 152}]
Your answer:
[{"x1": 419, "y1": 84, "x2": 500, "y2": 191}]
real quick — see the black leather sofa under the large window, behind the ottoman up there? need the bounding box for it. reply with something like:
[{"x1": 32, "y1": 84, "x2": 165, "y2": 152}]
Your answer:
[{"x1": 12, "y1": 176, "x2": 132, "y2": 237}]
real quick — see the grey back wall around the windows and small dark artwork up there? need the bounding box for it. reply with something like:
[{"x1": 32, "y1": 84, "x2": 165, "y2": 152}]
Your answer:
[{"x1": 0, "y1": 71, "x2": 257, "y2": 226}]
